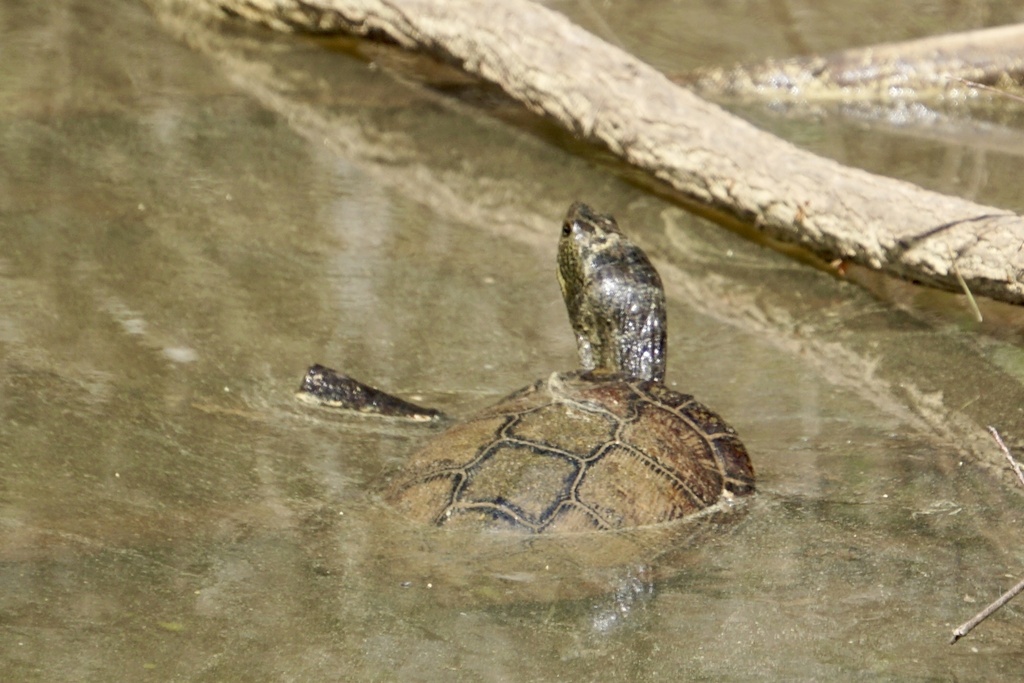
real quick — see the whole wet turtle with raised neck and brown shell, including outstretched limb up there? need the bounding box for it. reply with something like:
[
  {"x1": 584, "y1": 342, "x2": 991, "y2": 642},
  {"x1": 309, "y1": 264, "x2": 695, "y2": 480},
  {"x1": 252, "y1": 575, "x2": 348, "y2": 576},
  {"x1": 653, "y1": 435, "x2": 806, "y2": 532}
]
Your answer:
[{"x1": 300, "y1": 202, "x2": 755, "y2": 533}]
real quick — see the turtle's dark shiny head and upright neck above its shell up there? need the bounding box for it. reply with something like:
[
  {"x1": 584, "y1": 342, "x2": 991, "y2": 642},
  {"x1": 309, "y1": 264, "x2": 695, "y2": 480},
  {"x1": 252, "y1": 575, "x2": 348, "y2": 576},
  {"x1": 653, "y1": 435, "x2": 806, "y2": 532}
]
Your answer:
[{"x1": 558, "y1": 202, "x2": 666, "y2": 382}]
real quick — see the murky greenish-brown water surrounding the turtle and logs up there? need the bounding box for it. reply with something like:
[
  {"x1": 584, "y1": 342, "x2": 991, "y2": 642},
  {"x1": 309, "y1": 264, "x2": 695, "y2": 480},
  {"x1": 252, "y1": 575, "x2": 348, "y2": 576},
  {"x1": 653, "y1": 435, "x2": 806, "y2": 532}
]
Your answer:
[{"x1": 6, "y1": 0, "x2": 1024, "y2": 681}]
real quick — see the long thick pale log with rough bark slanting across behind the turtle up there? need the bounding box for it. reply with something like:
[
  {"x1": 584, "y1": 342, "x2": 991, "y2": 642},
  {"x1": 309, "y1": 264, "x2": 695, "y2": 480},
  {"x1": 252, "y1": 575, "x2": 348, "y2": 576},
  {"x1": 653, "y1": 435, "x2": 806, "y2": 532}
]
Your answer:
[{"x1": 172, "y1": 0, "x2": 1024, "y2": 304}]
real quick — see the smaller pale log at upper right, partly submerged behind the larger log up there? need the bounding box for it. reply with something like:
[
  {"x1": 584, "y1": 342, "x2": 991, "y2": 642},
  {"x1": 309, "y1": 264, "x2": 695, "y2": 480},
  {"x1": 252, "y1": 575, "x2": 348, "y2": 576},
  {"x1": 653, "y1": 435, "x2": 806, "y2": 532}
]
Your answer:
[{"x1": 674, "y1": 24, "x2": 1024, "y2": 102}]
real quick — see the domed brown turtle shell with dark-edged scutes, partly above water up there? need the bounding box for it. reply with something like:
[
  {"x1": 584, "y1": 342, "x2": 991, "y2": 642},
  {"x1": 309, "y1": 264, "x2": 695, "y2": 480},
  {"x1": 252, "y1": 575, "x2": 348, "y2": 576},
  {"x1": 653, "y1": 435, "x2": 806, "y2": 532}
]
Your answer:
[{"x1": 387, "y1": 373, "x2": 754, "y2": 532}]
